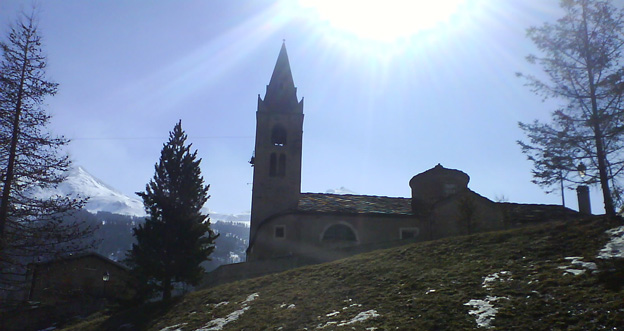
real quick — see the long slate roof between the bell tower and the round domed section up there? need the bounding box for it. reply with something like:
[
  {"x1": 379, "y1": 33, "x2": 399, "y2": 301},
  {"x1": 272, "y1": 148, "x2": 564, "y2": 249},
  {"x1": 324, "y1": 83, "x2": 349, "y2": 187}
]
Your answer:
[{"x1": 297, "y1": 193, "x2": 412, "y2": 215}]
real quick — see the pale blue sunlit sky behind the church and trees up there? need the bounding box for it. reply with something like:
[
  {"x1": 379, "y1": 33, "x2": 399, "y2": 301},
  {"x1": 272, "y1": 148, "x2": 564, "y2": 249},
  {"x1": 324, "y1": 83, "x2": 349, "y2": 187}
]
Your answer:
[{"x1": 0, "y1": 0, "x2": 604, "y2": 213}]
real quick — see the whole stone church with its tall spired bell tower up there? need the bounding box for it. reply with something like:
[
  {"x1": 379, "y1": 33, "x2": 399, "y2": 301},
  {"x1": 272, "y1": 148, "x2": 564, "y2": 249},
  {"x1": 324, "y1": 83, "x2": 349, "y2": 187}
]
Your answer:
[{"x1": 247, "y1": 44, "x2": 575, "y2": 263}]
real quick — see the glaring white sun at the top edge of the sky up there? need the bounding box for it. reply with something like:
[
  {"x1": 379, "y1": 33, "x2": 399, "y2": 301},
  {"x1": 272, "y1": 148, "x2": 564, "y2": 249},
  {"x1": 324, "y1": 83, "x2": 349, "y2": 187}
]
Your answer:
[{"x1": 299, "y1": 0, "x2": 468, "y2": 42}]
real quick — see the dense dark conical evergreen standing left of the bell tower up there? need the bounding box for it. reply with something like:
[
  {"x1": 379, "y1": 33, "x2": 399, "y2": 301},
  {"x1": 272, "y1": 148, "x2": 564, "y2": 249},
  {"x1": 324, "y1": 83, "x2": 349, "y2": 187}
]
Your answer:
[{"x1": 129, "y1": 121, "x2": 218, "y2": 300}]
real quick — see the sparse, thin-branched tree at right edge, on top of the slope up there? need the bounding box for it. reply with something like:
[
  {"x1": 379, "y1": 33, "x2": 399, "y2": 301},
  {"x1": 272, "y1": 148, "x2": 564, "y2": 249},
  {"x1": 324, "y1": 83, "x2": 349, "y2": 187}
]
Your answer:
[{"x1": 518, "y1": 0, "x2": 624, "y2": 216}]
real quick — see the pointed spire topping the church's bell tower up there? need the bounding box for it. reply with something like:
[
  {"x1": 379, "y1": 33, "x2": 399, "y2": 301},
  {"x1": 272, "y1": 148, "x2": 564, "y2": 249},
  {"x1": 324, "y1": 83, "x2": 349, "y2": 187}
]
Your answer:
[{"x1": 264, "y1": 41, "x2": 298, "y2": 111}]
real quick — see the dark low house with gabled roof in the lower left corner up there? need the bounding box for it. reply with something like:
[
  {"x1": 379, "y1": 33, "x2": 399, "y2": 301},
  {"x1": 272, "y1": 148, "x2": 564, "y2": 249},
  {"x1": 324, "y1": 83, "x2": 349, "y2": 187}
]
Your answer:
[{"x1": 0, "y1": 252, "x2": 135, "y2": 330}]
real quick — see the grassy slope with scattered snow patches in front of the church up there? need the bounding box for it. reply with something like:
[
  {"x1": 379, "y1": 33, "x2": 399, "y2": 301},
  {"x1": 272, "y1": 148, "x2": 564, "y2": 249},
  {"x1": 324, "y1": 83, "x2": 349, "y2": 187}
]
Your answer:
[{"x1": 66, "y1": 217, "x2": 624, "y2": 331}]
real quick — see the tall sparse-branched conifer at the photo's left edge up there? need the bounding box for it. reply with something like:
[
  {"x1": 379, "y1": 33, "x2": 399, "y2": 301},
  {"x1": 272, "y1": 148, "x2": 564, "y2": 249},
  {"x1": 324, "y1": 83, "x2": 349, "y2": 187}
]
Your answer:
[{"x1": 0, "y1": 11, "x2": 93, "y2": 300}]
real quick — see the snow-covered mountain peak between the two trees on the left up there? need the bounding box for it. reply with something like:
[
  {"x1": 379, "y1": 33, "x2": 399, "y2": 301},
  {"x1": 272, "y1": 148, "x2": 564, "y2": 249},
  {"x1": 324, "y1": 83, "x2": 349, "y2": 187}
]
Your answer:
[{"x1": 37, "y1": 166, "x2": 145, "y2": 217}]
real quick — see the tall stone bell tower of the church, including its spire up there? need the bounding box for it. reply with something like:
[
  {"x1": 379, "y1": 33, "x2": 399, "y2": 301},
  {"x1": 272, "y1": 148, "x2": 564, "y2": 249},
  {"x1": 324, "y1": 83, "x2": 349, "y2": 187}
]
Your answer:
[{"x1": 248, "y1": 44, "x2": 303, "y2": 252}]
